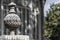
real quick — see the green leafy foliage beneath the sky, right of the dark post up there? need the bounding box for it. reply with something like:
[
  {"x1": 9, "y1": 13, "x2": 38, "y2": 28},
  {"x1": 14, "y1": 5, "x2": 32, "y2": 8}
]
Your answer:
[{"x1": 44, "y1": 4, "x2": 60, "y2": 40}]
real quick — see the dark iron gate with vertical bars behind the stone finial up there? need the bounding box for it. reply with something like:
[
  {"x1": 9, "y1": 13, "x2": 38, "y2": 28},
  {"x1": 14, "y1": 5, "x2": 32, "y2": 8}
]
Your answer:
[{"x1": 0, "y1": 0, "x2": 45, "y2": 40}]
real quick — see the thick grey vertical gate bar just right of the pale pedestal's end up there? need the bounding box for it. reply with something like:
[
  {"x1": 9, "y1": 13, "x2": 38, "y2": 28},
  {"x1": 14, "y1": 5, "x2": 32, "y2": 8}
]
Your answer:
[{"x1": 29, "y1": 0, "x2": 34, "y2": 40}]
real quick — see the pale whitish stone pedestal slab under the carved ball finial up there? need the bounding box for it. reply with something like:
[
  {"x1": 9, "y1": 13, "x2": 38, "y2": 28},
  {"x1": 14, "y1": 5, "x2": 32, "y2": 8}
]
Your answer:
[{"x1": 0, "y1": 35, "x2": 29, "y2": 40}]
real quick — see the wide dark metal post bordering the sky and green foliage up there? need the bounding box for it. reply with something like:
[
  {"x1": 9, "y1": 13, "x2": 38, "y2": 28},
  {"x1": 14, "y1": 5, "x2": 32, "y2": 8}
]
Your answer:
[{"x1": 38, "y1": 0, "x2": 44, "y2": 40}]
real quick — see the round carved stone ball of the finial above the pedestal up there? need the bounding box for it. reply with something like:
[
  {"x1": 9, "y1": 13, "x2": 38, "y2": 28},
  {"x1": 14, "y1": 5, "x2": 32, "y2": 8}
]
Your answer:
[{"x1": 4, "y1": 14, "x2": 21, "y2": 28}]
